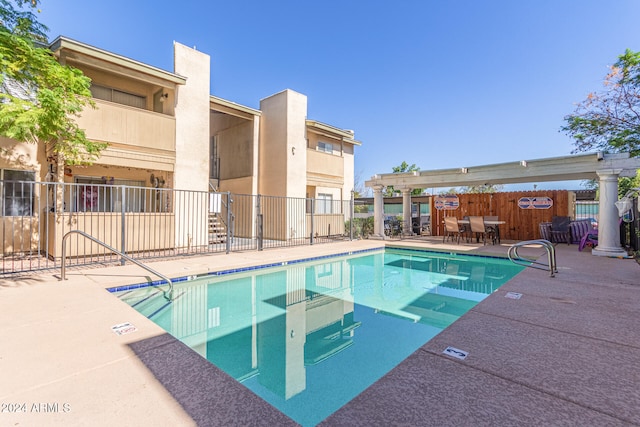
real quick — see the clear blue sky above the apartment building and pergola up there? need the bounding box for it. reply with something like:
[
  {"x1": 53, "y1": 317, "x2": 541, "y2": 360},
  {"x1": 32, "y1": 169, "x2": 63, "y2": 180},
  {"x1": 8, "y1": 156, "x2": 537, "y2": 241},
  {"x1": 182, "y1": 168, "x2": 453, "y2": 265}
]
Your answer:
[{"x1": 40, "y1": 0, "x2": 640, "y2": 189}]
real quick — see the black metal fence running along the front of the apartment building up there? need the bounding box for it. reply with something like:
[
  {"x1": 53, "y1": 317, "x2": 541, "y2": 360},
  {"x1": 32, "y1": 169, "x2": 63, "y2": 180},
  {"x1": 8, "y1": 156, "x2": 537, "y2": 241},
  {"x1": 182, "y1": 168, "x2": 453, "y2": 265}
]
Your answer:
[{"x1": 0, "y1": 181, "x2": 353, "y2": 276}]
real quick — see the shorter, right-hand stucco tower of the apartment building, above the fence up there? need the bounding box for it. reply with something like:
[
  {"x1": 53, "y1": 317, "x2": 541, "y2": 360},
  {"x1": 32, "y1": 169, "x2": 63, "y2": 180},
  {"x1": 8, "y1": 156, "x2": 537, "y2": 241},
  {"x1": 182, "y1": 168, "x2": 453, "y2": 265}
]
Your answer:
[{"x1": 258, "y1": 89, "x2": 307, "y2": 197}]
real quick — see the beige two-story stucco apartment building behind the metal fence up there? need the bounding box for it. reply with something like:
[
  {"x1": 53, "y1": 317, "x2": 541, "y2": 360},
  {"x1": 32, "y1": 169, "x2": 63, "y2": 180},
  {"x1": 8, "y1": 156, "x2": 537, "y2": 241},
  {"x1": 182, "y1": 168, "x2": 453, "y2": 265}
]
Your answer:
[{"x1": 0, "y1": 37, "x2": 360, "y2": 253}]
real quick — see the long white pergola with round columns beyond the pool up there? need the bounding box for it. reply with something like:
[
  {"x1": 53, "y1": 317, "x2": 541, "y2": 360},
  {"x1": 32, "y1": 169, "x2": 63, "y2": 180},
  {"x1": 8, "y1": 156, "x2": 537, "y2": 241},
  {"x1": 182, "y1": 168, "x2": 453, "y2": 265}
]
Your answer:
[{"x1": 365, "y1": 152, "x2": 640, "y2": 256}]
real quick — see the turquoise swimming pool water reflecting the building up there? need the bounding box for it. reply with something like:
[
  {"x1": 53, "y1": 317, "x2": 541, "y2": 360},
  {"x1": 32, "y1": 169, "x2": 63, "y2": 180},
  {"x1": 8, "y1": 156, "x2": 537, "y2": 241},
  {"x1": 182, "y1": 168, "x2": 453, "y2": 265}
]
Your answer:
[{"x1": 118, "y1": 249, "x2": 523, "y2": 426}]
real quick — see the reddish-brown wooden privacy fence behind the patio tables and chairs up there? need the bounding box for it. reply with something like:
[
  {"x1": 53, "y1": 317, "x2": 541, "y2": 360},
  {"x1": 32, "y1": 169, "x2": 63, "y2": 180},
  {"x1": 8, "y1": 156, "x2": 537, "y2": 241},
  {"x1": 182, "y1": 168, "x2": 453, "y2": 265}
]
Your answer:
[{"x1": 431, "y1": 190, "x2": 575, "y2": 240}]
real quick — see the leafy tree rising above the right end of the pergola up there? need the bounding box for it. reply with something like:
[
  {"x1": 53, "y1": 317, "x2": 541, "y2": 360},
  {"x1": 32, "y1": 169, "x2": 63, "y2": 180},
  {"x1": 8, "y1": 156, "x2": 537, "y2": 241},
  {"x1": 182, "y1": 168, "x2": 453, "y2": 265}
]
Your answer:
[{"x1": 561, "y1": 49, "x2": 640, "y2": 157}]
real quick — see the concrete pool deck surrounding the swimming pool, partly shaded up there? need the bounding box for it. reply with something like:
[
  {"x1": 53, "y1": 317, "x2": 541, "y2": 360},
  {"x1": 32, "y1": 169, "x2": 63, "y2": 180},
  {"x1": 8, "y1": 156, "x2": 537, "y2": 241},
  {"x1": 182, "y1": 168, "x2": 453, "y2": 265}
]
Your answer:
[{"x1": 0, "y1": 238, "x2": 640, "y2": 426}]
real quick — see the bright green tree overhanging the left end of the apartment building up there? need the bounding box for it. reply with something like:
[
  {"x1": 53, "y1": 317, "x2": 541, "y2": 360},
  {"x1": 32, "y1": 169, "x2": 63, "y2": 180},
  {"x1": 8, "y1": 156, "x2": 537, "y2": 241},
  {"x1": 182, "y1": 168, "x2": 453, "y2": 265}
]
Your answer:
[{"x1": 0, "y1": 0, "x2": 106, "y2": 164}]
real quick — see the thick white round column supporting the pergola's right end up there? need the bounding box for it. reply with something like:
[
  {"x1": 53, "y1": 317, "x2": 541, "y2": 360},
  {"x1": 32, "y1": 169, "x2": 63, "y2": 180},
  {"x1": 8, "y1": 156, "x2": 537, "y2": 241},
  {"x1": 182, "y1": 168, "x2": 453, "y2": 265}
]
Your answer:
[{"x1": 591, "y1": 169, "x2": 627, "y2": 257}]
